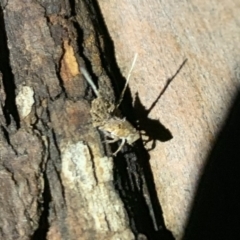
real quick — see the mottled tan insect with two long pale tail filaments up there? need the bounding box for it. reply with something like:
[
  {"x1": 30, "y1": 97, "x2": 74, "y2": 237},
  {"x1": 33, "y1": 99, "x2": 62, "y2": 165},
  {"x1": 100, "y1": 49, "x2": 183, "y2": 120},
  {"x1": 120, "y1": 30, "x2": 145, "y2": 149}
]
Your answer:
[{"x1": 80, "y1": 55, "x2": 140, "y2": 155}]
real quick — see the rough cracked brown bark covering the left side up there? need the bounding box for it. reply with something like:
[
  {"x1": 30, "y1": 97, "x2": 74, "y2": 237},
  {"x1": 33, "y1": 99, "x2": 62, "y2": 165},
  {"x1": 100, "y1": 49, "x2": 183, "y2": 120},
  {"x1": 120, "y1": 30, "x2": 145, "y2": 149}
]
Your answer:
[{"x1": 0, "y1": 0, "x2": 167, "y2": 240}]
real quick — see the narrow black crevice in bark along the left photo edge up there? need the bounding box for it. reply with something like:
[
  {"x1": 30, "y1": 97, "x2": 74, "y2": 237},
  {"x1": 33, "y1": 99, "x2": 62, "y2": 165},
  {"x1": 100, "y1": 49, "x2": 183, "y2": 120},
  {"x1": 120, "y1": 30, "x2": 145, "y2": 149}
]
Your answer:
[{"x1": 0, "y1": 8, "x2": 20, "y2": 128}]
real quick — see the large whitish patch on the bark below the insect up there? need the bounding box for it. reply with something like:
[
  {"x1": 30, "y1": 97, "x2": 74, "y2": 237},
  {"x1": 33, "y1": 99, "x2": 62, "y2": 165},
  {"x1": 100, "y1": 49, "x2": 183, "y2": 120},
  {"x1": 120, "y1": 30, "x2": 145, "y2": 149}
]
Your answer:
[{"x1": 60, "y1": 141, "x2": 134, "y2": 237}]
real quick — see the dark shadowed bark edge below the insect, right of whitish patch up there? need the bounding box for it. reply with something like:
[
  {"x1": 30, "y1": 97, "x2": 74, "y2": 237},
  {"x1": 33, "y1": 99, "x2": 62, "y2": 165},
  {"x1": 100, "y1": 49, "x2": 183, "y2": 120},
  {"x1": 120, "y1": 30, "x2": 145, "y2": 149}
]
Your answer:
[{"x1": 114, "y1": 140, "x2": 174, "y2": 240}]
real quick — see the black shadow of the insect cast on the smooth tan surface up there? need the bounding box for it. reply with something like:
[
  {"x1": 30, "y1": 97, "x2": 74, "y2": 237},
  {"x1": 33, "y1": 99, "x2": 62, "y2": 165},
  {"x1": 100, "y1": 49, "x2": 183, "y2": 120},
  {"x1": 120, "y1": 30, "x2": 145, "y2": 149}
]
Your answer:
[{"x1": 134, "y1": 59, "x2": 187, "y2": 151}]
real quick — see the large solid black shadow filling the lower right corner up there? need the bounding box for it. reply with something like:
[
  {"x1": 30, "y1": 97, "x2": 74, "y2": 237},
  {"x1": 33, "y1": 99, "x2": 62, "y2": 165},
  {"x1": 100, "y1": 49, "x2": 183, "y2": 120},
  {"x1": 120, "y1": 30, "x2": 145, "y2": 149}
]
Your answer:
[{"x1": 183, "y1": 91, "x2": 240, "y2": 240}]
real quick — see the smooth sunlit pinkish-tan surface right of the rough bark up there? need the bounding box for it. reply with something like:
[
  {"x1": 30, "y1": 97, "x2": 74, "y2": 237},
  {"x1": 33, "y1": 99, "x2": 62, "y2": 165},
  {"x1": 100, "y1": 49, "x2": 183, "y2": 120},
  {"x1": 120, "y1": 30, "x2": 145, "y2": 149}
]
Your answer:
[{"x1": 99, "y1": 0, "x2": 240, "y2": 239}]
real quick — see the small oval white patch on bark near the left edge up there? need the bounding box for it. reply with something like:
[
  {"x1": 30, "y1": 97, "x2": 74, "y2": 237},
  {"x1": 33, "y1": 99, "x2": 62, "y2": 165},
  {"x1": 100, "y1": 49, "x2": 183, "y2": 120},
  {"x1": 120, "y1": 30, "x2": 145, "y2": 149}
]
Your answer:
[{"x1": 16, "y1": 86, "x2": 35, "y2": 118}]
